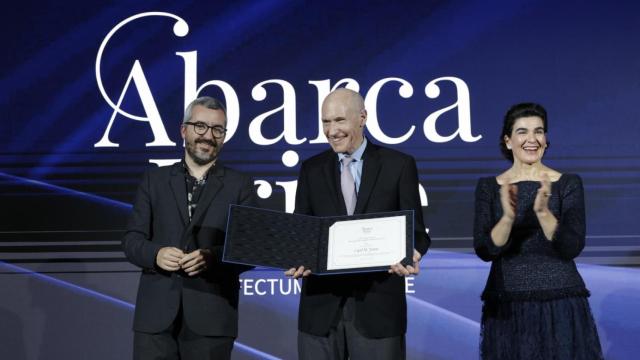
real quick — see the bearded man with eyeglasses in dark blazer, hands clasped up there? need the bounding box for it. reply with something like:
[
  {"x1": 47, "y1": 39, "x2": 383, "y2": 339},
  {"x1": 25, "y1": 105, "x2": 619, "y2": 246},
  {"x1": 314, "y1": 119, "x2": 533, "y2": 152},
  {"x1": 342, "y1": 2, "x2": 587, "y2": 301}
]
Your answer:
[{"x1": 122, "y1": 97, "x2": 256, "y2": 359}]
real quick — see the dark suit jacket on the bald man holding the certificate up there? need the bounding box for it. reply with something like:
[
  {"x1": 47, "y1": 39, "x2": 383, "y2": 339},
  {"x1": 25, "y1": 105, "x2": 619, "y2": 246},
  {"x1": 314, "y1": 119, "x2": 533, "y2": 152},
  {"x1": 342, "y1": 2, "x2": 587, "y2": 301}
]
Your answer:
[{"x1": 295, "y1": 141, "x2": 431, "y2": 338}]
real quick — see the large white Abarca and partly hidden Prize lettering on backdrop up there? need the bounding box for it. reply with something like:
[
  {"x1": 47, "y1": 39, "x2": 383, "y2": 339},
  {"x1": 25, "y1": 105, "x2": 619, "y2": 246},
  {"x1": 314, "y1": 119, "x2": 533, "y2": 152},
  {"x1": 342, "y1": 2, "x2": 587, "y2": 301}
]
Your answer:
[{"x1": 94, "y1": 12, "x2": 482, "y2": 217}]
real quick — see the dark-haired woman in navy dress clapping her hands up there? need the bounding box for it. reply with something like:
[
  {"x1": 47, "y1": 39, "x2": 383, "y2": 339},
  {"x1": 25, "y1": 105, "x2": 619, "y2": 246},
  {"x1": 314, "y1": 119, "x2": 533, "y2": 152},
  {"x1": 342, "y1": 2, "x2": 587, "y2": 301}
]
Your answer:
[{"x1": 473, "y1": 103, "x2": 603, "y2": 360}]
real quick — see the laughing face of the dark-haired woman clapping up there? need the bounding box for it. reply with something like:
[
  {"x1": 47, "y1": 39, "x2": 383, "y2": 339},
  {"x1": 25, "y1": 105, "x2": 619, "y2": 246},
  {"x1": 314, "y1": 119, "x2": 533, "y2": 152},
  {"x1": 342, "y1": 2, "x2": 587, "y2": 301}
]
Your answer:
[{"x1": 504, "y1": 116, "x2": 547, "y2": 164}]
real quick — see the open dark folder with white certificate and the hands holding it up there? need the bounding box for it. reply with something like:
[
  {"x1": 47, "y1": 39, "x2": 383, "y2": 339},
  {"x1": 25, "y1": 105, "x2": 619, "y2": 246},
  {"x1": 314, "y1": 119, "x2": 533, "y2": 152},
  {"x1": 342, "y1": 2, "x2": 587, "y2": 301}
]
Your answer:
[{"x1": 223, "y1": 206, "x2": 419, "y2": 277}]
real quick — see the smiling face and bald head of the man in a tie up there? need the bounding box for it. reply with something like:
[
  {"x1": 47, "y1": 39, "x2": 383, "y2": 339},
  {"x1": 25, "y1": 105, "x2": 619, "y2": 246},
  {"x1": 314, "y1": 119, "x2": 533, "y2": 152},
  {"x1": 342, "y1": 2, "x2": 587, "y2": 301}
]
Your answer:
[{"x1": 322, "y1": 89, "x2": 367, "y2": 154}]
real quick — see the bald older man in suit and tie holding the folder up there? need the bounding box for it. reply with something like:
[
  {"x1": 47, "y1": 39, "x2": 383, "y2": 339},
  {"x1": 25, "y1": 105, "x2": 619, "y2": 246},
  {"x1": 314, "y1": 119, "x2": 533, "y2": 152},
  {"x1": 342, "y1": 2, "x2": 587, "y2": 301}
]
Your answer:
[{"x1": 285, "y1": 88, "x2": 430, "y2": 360}]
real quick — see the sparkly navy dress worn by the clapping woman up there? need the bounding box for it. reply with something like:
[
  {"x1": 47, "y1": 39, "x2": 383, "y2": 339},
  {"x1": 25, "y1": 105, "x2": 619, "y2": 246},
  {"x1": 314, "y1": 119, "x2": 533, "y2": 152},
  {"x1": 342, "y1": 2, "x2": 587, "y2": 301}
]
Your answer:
[{"x1": 473, "y1": 174, "x2": 603, "y2": 360}]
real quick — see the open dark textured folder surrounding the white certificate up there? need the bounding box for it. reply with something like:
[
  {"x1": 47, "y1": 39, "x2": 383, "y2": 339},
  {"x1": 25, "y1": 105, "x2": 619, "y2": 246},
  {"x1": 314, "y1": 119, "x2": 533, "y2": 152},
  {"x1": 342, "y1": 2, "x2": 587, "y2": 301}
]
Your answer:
[{"x1": 223, "y1": 205, "x2": 413, "y2": 274}]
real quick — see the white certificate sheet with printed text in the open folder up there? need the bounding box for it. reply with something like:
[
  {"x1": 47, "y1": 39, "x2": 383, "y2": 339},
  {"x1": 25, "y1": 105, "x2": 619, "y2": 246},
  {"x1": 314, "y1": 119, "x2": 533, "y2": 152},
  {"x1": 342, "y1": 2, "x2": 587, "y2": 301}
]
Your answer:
[{"x1": 327, "y1": 216, "x2": 407, "y2": 270}]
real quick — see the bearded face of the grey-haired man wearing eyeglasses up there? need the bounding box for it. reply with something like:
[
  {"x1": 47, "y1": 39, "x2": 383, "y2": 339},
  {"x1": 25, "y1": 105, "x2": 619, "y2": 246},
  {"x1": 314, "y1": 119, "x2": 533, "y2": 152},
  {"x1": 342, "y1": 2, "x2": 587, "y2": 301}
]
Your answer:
[{"x1": 180, "y1": 105, "x2": 226, "y2": 165}]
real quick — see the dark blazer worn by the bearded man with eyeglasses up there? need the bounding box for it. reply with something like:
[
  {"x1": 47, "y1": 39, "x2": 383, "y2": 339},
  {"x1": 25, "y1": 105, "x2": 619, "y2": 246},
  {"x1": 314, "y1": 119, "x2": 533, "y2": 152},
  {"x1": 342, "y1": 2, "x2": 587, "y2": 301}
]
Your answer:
[{"x1": 122, "y1": 163, "x2": 255, "y2": 337}]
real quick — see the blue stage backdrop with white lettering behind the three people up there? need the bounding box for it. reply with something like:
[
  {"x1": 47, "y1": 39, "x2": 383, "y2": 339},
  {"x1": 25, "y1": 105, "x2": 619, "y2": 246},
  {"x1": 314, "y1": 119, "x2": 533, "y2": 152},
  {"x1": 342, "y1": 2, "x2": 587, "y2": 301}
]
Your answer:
[{"x1": 0, "y1": 0, "x2": 640, "y2": 359}]
